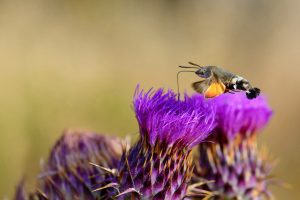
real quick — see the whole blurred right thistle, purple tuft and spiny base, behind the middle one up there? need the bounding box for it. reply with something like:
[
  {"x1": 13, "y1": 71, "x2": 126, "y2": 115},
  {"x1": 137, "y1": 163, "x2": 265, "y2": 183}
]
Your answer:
[{"x1": 192, "y1": 93, "x2": 272, "y2": 199}]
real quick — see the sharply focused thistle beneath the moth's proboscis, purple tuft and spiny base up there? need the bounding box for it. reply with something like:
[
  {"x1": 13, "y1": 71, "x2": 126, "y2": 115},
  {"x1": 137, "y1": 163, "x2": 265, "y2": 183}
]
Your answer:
[{"x1": 118, "y1": 89, "x2": 215, "y2": 200}]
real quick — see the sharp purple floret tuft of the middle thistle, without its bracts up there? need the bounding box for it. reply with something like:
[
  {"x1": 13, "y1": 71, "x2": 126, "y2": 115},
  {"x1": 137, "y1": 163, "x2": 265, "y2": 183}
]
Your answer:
[{"x1": 134, "y1": 88, "x2": 215, "y2": 148}]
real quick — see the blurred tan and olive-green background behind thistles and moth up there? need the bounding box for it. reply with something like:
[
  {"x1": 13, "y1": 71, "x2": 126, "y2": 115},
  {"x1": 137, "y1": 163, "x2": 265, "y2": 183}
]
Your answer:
[{"x1": 0, "y1": 0, "x2": 300, "y2": 199}]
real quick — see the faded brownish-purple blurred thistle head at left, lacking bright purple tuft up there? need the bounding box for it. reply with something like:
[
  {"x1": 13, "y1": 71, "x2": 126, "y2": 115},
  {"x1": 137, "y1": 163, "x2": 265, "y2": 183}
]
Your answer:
[{"x1": 15, "y1": 132, "x2": 122, "y2": 200}]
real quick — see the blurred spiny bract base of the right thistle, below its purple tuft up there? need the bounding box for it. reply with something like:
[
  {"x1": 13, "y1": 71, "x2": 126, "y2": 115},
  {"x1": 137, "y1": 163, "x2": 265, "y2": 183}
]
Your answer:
[{"x1": 194, "y1": 136, "x2": 273, "y2": 200}]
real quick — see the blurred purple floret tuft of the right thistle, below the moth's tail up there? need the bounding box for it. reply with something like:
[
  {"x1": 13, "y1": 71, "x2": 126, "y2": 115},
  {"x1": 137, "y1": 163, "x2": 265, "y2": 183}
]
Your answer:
[{"x1": 212, "y1": 92, "x2": 272, "y2": 139}]
